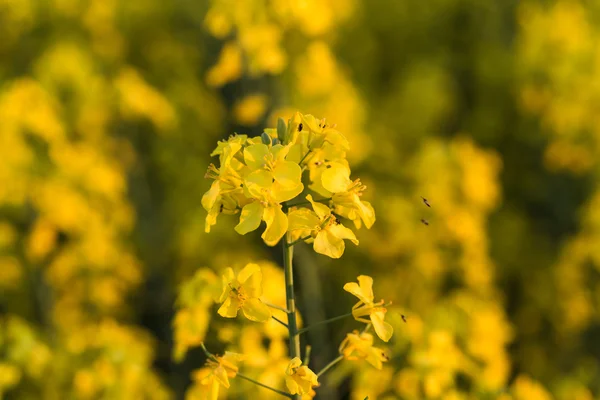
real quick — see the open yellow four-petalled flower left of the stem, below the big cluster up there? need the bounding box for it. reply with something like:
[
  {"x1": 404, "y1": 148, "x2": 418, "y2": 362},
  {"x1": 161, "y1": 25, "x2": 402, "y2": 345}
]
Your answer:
[{"x1": 218, "y1": 264, "x2": 271, "y2": 322}]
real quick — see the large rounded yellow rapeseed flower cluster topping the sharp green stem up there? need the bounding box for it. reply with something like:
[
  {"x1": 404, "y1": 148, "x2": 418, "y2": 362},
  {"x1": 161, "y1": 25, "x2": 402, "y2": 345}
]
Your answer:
[{"x1": 202, "y1": 113, "x2": 375, "y2": 258}]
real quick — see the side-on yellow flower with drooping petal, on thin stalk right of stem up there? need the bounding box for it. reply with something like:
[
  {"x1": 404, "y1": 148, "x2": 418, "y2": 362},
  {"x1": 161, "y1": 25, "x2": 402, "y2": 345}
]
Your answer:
[{"x1": 344, "y1": 275, "x2": 394, "y2": 342}]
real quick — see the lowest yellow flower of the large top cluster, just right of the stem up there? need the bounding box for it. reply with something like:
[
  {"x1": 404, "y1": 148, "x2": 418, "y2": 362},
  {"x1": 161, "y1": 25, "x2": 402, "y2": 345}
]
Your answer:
[{"x1": 289, "y1": 195, "x2": 358, "y2": 258}]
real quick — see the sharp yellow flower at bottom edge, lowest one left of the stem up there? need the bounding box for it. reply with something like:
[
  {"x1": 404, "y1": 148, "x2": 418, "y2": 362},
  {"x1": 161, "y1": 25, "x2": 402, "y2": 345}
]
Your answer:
[{"x1": 193, "y1": 351, "x2": 244, "y2": 400}]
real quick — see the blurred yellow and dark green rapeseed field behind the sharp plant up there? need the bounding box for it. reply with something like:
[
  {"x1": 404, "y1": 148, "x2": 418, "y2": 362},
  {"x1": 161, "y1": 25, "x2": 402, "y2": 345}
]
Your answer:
[{"x1": 0, "y1": 0, "x2": 600, "y2": 400}]
